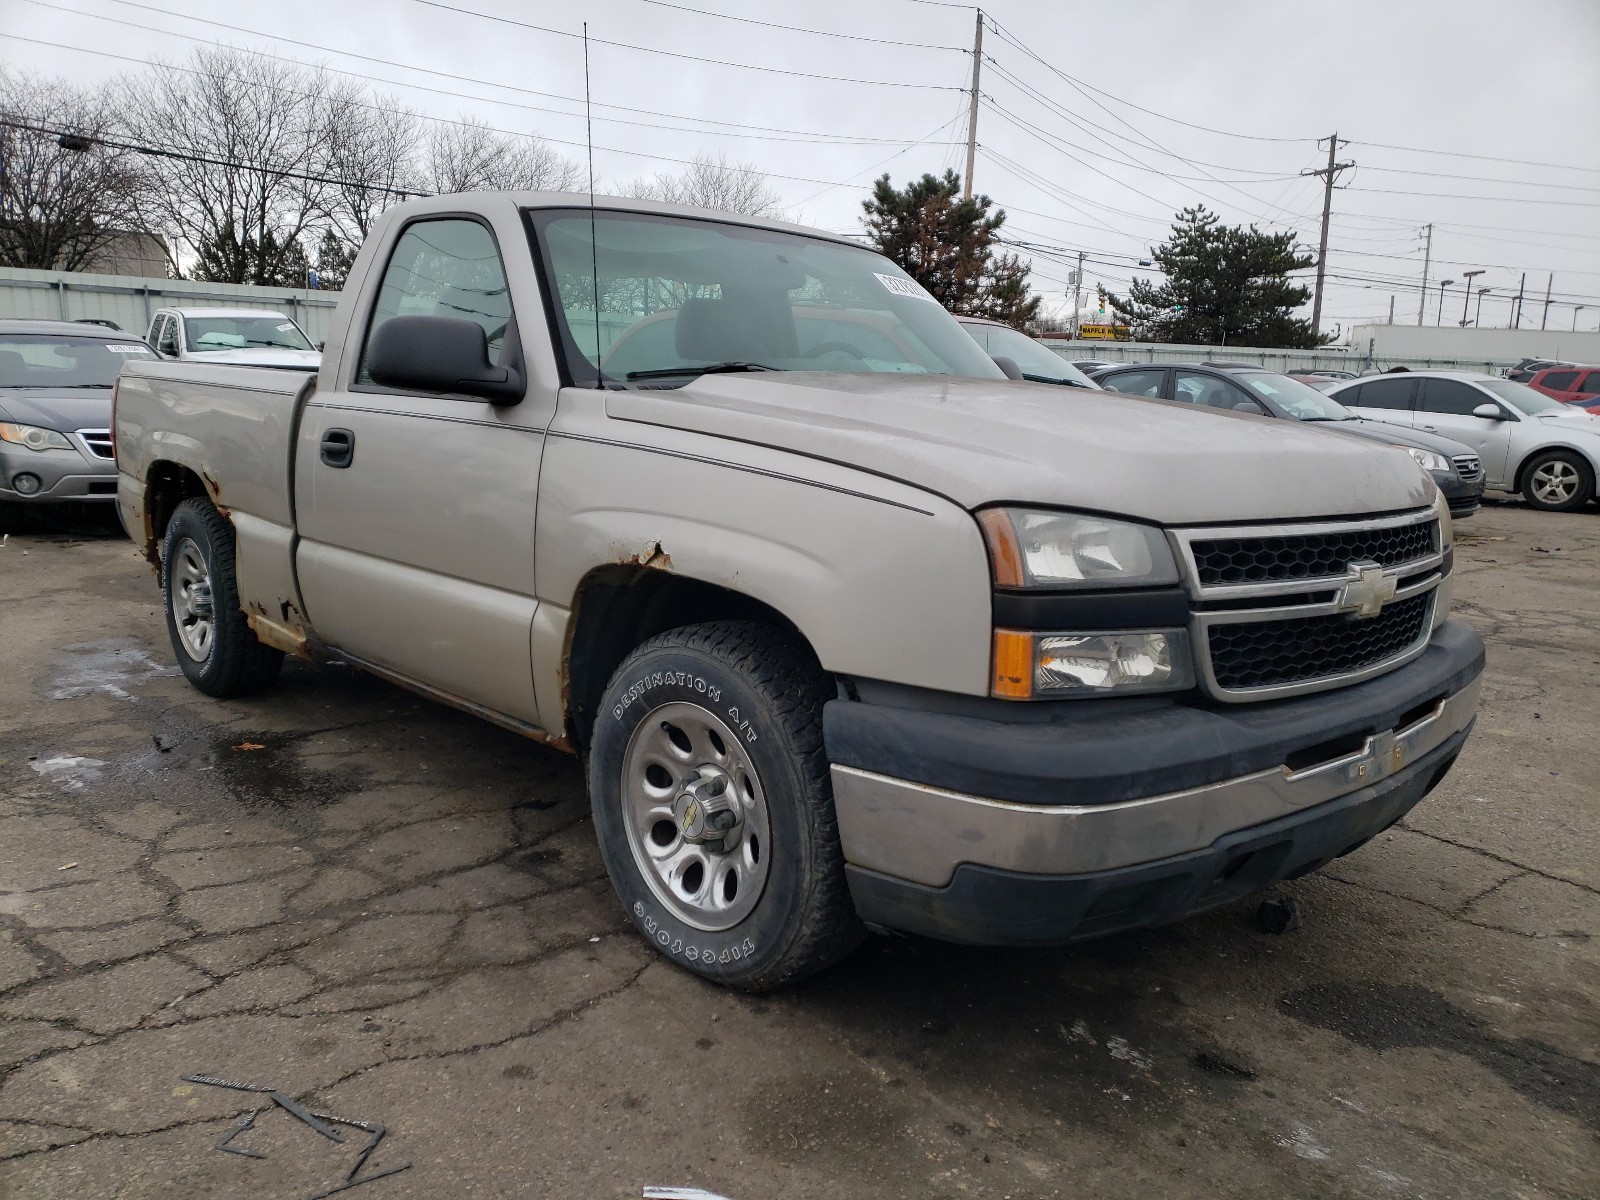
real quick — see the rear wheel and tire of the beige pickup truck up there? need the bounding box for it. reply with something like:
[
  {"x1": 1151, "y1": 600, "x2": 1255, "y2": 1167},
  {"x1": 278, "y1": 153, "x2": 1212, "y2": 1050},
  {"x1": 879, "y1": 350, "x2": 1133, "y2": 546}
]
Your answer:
[{"x1": 162, "y1": 498, "x2": 283, "y2": 699}]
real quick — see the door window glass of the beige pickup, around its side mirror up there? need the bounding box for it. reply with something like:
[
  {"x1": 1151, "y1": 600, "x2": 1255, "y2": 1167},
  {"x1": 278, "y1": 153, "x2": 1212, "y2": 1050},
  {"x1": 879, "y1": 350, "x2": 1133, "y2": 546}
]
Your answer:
[{"x1": 355, "y1": 218, "x2": 512, "y2": 384}]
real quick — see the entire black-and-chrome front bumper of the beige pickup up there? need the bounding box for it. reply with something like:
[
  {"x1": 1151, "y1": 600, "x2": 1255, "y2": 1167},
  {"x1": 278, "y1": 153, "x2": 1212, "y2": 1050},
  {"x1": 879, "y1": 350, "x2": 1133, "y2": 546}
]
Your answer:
[{"x1": 824, "y1": 622, "x2": 1483, "y2": 944}]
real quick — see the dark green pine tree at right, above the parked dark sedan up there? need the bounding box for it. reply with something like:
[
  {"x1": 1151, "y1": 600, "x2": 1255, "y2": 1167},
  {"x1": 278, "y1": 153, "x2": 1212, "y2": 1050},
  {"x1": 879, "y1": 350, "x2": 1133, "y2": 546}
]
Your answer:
[{"x1": 1099, "y1": 205, "x2": 1331, "y2": 349}]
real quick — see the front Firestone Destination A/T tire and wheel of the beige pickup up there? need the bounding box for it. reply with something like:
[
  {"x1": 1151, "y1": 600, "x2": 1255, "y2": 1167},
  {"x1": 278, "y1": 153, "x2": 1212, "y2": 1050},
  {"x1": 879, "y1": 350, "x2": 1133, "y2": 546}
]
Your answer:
[{"x1": 589, "y1": 621, "x2": 864, "y2": 990}]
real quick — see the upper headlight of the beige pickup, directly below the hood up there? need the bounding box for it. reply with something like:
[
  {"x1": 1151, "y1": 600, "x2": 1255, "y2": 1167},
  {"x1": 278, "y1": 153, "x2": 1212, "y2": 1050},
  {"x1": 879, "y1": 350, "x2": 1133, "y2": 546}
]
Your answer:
[{"x1": 978, "y1": 509, "x2": 1178, "y2": 589}]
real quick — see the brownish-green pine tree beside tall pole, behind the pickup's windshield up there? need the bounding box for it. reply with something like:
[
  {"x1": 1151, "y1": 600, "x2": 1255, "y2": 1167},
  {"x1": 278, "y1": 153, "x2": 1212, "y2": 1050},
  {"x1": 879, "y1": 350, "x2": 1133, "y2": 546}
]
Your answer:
[{"x1": 861, "y1": 171, "x2": 1038, "y2": 330}]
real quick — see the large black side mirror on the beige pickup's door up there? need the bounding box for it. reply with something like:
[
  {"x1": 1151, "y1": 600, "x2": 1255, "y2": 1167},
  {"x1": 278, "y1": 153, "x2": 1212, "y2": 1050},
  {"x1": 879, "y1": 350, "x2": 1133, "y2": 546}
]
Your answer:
[{"x1": 366, "y1": 317, "x2": 526, "y2": 405}]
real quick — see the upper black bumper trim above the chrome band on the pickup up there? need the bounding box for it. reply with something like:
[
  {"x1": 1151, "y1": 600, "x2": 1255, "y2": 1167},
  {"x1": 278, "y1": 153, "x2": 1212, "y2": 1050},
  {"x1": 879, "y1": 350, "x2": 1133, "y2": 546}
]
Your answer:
[{"x1": 822, "y1": 621, "x2": 1483, "y2": 805}]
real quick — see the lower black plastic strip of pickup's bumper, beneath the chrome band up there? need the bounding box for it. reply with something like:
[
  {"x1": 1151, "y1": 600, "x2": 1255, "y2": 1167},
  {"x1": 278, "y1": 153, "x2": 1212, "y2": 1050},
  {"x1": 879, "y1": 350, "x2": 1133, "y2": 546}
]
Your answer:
[{"x1": 845, "y1": 725, "x2": 1472, "y2": 946}]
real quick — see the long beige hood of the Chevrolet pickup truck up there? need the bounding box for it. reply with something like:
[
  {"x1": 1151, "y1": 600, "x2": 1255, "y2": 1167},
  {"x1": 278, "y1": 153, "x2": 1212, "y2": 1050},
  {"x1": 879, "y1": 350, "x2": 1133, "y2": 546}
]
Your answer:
[{"x1": 606, "y1": 373, "x2": 1434, "y2": 525}]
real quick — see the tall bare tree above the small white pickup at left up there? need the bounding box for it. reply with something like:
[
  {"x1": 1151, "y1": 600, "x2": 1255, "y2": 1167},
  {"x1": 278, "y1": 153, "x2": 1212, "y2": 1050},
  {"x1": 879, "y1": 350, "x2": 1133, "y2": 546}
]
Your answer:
[{"x1": 118, "y1": 46, "x2": 331, "y2": 283}]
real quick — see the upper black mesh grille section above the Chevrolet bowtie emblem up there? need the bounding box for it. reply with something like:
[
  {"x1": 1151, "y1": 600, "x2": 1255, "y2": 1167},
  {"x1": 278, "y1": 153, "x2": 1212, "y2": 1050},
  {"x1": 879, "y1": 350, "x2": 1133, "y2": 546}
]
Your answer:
[{"x1": 1190, "y1": 520, "x2": 1438, "y2": 587}]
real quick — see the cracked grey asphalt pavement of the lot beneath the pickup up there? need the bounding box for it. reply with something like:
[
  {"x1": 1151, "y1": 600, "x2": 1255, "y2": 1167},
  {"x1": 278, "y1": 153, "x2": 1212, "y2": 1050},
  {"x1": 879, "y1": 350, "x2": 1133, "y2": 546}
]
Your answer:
[{"x1": 0, "y1": 504, "x2": 1600, "y2": 1200}]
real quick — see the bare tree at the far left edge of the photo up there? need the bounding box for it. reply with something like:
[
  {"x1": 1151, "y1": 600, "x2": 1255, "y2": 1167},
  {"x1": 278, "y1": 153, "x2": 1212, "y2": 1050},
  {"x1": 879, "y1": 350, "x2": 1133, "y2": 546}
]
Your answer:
[{"x1": 0, "y1": 67, "x2": 138, "y2": 270}]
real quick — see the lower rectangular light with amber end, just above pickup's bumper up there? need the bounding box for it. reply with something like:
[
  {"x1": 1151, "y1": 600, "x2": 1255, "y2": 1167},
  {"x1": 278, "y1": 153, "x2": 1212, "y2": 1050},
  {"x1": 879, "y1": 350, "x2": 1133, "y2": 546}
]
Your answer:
[{"x1": 994, "y1": 629, "x2": 1195, "y2": 699}]
